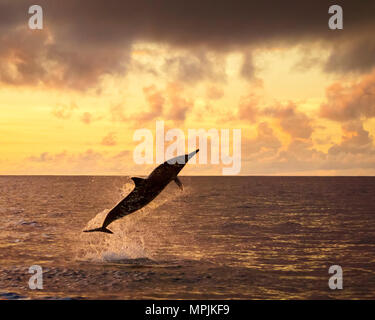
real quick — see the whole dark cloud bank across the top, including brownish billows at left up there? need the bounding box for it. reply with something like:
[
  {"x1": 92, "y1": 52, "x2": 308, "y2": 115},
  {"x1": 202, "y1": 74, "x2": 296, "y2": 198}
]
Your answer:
[{"x1": 0, "y1": 0, "x2": 375, "y2": 89}]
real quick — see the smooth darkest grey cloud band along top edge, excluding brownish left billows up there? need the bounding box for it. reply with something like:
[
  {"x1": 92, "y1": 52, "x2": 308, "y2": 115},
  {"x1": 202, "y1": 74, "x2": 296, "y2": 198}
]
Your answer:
[{"x1": 41, "y1": 0, "x2": 375, "y2": 48}]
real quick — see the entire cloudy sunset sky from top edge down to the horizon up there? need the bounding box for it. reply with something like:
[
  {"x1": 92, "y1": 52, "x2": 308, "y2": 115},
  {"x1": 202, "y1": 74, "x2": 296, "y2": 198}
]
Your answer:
[{"x1": 0, "y1": 0, "x2": 375, "y2": 175}]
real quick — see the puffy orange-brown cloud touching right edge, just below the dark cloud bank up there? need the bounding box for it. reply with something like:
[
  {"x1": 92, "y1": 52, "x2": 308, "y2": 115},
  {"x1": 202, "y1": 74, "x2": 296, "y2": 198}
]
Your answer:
[{"x1": 320, "y1": 72, "x2": 375, "y2": 121}]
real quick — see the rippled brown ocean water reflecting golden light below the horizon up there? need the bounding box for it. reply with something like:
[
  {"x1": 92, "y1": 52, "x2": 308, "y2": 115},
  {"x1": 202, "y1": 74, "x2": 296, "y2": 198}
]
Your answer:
[{"x1": 0, "y1": 176, "x2": 375, "y2": 299}]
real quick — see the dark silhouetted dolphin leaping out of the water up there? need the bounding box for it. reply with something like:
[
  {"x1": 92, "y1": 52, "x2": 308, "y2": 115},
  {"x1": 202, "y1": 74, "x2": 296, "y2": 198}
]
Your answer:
[{"x1": 83, "y1": 149, "x2": 199, "y2": 233}]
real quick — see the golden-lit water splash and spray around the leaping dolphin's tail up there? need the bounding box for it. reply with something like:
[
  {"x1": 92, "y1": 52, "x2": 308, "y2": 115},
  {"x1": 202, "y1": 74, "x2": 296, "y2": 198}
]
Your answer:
[{"x1": 76, "y1": 182, "x2": 189, "y2": 262}]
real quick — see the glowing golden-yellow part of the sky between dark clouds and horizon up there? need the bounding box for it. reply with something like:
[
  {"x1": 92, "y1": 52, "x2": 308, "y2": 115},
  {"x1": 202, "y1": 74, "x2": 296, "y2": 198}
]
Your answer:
[{"x1": 0, "y1": 1, "x2": 375, "y2": 175}]
